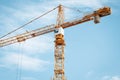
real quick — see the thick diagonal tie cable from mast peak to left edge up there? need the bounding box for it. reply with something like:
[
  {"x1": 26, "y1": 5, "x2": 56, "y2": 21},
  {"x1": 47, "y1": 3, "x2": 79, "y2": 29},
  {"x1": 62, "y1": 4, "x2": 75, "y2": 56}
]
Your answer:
[{"x1": 0, "y1": 6, "x2": 58, "y2": 39}]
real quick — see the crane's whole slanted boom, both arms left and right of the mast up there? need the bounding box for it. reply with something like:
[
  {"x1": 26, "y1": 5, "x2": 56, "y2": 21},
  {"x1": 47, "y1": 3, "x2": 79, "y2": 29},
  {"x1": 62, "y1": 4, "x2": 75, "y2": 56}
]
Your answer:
[{"x1": 0, "y1": 7, "x2": 111, "y2": 47}]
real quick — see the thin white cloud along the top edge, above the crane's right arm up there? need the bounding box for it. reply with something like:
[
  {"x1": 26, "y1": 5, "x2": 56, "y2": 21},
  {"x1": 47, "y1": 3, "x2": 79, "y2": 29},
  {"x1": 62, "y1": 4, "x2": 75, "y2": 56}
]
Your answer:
[{"x1": 53, "y1": 0, "x2": 108, "y2": 9}]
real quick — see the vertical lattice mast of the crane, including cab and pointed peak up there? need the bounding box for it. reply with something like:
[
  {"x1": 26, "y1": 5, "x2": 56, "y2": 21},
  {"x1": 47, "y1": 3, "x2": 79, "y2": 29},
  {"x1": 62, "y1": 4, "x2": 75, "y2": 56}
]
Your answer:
[{"x1": 53, "y1": 5, "x2": 65, "y2": 80}]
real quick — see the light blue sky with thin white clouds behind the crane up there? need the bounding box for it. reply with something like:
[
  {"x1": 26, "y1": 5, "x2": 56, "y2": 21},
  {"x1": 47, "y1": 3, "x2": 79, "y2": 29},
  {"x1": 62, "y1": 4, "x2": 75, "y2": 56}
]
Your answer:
[{"x1": 0, "y1": 0, "x2": 120, "y2": 80}]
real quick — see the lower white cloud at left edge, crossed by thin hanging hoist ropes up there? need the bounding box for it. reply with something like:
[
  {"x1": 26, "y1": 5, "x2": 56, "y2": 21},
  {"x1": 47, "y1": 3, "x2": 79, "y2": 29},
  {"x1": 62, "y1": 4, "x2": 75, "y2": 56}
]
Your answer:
[{"x1": 0, "y1": 53, "x2": 50, "y2": 71}]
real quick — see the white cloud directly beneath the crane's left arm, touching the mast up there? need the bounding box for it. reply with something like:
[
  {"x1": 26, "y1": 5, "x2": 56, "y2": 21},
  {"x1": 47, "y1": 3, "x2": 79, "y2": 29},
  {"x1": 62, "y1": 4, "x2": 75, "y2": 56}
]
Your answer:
[{"x1": 2, "y1": 35, "x2": 54, "y2": 56}]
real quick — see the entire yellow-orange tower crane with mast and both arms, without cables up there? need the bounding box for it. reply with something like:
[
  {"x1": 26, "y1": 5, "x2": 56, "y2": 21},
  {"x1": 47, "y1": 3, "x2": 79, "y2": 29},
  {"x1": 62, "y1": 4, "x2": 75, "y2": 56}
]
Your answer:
[{"x1": 0, "y1": 5, "x2": 111, "y2": 80}]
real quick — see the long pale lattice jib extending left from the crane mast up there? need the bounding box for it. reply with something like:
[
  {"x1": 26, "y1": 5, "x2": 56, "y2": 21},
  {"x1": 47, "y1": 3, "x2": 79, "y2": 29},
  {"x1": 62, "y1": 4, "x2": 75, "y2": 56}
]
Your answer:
[{"x1": 0, "y1": 24, "x2": 55, "y2": 47}]
